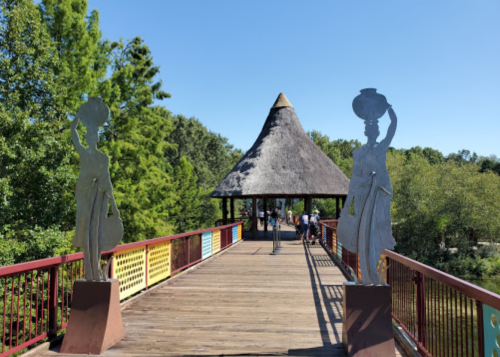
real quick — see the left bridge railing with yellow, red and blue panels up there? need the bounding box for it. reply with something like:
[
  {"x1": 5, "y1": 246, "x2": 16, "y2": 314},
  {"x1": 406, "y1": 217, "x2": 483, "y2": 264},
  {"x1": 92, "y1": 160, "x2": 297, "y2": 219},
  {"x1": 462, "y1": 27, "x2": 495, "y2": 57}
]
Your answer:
[{"x1": 0, "y1": 222, "x2": 243, "y2": 357}]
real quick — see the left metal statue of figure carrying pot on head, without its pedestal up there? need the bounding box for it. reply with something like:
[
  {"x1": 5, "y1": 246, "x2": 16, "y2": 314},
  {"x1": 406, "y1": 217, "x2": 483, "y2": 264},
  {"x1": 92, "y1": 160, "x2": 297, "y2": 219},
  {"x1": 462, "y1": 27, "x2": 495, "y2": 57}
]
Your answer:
[{"x1": 71, "y1": 97, "x2": 123, "y2": 281}]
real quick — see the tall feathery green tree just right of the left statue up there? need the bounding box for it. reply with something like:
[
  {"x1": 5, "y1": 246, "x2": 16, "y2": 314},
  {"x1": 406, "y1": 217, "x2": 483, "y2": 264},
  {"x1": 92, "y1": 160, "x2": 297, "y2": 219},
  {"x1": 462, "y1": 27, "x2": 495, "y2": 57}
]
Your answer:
[{"x1": 96, "y1": 37, "x2": 175, "y2": 242}]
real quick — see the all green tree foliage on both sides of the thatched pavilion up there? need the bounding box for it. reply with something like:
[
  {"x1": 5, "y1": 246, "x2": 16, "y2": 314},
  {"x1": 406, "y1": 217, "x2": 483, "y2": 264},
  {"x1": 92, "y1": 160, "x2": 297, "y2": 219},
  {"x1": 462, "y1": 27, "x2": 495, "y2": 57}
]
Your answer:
[{"x1": 0, "y1": 0, "x2": 500, "y2": 284}]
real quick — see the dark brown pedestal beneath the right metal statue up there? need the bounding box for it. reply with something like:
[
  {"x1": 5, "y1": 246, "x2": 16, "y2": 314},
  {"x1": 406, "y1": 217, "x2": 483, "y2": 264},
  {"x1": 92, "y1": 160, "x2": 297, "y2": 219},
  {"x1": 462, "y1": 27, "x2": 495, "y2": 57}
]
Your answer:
[{"x1": 342, "y1": 282, "x2": 396, "y2": 357}]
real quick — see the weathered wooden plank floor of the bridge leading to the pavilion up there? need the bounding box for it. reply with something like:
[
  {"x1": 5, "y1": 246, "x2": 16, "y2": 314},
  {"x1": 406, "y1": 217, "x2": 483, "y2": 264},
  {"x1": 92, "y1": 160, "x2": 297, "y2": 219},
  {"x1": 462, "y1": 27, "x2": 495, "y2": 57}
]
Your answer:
[{"x1": 47, "y1": 225, "x2": 401, "y2": 357}]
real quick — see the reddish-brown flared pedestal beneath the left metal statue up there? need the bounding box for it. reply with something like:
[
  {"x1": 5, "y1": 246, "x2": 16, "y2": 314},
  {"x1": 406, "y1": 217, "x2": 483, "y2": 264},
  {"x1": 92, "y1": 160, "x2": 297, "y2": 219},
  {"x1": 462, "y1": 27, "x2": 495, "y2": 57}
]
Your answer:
[{"x1": 61, "y1": 279, "x2": 125, "y2": 355}]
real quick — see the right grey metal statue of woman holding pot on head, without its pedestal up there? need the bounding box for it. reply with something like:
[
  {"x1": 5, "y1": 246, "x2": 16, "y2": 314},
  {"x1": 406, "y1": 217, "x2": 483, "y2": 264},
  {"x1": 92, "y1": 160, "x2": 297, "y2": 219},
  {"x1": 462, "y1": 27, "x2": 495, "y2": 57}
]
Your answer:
[{"x1": 337, "y1": 88, "x2": 397, "y2": 285}]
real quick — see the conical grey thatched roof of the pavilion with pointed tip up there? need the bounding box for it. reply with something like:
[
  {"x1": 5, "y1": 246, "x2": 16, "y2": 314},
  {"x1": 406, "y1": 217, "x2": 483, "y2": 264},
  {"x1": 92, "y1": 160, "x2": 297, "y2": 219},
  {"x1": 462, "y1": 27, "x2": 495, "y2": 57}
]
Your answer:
[{"x1": 210, "y1": 93, "x2": 349, "y2": 197}]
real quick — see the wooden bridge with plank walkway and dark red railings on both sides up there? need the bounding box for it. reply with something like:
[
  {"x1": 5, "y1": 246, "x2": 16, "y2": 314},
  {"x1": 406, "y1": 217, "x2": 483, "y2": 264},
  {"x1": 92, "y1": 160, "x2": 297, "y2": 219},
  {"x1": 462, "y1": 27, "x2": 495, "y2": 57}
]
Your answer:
[{"x1": 0, "y1": 221, "x2": 500, "y2": 357}]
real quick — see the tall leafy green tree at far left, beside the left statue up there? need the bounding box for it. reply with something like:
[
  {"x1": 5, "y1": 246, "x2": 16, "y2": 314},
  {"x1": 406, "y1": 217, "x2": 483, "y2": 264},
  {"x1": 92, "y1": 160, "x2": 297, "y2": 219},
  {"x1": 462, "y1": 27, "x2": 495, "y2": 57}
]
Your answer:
[{"x1": 0, "y1": 0, "x2": 75, "y2": 227}]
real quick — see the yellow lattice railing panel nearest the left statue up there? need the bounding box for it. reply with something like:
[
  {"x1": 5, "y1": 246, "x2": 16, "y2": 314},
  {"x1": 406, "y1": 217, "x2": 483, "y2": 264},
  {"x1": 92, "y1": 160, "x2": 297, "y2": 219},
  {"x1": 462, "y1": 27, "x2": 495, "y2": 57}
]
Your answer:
[{"x1": 113, "y1": 246, "x2": 146, "y2": 300}]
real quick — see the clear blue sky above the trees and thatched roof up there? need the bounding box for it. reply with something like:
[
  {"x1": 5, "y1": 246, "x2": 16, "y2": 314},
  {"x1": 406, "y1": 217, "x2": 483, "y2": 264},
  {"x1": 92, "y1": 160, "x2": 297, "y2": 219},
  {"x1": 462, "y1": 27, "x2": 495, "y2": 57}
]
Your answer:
[{"x1": 89, "y1": 0, "x2": 500, "y2": 156}]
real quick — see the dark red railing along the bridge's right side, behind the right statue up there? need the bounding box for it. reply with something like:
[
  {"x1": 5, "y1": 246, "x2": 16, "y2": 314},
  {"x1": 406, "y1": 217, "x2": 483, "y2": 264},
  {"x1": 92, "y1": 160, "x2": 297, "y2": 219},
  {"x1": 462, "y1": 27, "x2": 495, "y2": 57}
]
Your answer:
[{"x1": 320, "y1": 222, "x2": 500, "y2": 357}]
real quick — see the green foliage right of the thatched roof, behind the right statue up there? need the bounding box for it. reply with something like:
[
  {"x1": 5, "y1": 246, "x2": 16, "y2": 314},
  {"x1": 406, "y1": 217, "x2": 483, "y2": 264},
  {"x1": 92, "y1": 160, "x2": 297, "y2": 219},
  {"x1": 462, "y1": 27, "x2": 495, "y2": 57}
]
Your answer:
[{"x1": 310, "y1": 132, "x2": 500, "y2": 277}]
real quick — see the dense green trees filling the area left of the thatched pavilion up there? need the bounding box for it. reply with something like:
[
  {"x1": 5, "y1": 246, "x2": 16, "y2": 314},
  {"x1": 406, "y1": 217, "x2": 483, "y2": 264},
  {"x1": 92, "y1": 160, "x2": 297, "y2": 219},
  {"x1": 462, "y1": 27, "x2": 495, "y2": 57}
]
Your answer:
[{"x1": 0, "y1": 0, "x2": 241, "y2": 265}]
